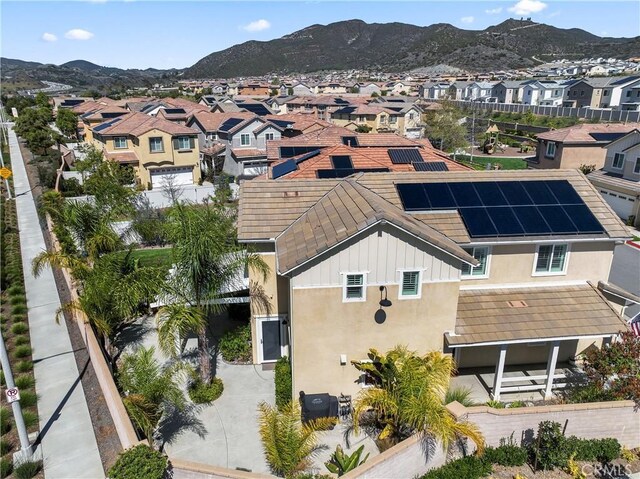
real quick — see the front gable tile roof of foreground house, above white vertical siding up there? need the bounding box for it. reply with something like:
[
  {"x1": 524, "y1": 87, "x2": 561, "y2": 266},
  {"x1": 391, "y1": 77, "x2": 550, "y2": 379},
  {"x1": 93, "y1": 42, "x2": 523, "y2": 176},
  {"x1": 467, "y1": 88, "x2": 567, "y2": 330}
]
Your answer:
[{"x1": 276, "y1": 179, "x2": 477, "y2": 274}]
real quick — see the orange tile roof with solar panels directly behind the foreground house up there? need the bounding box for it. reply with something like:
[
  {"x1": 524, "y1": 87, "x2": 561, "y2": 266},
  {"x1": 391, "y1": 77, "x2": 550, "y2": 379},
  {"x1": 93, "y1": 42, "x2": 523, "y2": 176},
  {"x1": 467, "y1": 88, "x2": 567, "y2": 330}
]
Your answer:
[{"x1": 267, "y1": 144, "x2": 470, "y2": 180}]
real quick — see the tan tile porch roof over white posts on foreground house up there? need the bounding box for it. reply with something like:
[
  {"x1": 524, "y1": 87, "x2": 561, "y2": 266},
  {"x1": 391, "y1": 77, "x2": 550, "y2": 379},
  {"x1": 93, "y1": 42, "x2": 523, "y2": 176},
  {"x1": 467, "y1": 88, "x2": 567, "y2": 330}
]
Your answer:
[{"x1": 445, "y1": 284, "x2": 628, "y2": 346}]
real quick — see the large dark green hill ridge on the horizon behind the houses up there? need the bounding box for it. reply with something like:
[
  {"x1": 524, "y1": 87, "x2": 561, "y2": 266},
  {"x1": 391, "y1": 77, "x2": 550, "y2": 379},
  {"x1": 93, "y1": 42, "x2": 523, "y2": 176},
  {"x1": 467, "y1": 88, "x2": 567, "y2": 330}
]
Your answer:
[{"x1": 184, "y1": 19, "x2": 640, "y2": 78}]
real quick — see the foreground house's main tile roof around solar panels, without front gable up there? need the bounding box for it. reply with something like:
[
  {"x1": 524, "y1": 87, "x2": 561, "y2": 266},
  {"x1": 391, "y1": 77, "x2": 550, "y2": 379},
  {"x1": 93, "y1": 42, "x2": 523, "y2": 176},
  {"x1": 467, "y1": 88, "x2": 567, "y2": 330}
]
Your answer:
[{"x1": 238, "y1": 169, "x2": 631, "y2": 243}]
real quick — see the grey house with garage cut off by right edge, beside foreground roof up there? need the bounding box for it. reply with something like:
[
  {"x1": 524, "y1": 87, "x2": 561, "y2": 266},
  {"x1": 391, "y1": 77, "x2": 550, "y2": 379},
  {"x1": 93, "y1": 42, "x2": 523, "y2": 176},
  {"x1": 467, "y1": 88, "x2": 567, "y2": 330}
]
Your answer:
[{"x1": 588, "y1": 128, "x2": 640, "y2": 227}]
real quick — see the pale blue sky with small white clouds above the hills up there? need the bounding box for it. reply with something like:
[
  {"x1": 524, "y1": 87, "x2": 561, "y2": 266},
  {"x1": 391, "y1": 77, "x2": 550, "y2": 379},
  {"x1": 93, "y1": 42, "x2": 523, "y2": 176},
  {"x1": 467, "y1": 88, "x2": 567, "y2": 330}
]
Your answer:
[{"x1": 0, "y1": 0, "x2": 640, "y2": 68}]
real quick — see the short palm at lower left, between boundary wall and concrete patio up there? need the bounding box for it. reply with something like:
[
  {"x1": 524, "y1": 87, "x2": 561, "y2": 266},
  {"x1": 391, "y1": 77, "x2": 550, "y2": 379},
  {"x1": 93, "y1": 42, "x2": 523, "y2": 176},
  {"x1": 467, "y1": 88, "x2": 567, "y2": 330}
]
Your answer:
[{"x1": 117, "y1": 347, "x2": 186, "y2": 446}]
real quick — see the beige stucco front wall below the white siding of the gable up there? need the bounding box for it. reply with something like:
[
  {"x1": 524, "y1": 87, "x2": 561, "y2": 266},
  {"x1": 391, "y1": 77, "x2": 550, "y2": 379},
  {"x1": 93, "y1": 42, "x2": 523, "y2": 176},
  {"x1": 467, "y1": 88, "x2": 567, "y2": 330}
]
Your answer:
[{"x1": 291, "y1": 282, "x2": 458, "y2": 397}]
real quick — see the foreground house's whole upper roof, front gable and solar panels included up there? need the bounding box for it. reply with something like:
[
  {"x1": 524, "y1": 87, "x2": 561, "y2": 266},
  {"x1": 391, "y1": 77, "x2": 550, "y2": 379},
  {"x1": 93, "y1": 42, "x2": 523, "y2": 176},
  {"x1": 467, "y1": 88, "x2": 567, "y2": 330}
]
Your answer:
[{"x1": 238, "y1": 170, "x2": 630, "y2": 258}]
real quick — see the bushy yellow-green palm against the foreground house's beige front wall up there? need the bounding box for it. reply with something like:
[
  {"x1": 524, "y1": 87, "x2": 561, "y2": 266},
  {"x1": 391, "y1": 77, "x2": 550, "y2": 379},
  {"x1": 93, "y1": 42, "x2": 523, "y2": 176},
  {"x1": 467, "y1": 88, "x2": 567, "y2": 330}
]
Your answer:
[{"x1": 352, "y1": 346, "x2": 484, "y2": 453}]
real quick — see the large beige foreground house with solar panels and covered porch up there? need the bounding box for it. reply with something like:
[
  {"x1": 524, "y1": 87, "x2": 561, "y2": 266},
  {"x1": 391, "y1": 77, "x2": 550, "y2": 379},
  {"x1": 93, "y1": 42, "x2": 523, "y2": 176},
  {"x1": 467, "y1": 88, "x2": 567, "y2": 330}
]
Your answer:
[{"x1": 238, "y1": 170, "x2": 629, "y2": 399}]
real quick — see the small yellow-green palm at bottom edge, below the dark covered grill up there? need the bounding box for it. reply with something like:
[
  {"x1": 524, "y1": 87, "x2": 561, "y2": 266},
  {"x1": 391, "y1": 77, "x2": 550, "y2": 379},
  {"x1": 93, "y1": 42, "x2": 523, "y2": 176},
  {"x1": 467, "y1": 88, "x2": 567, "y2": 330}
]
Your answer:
[{"x1": 258, "y1": 401, "x2": 335, "y2": 477}]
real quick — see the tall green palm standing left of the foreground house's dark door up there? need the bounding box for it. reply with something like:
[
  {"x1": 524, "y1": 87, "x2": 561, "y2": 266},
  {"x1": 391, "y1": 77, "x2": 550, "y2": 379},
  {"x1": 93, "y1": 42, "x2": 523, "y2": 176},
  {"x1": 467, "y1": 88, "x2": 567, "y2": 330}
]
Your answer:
[{"x1": 157, "y1": 202, "x2": 269, "y2": 384}]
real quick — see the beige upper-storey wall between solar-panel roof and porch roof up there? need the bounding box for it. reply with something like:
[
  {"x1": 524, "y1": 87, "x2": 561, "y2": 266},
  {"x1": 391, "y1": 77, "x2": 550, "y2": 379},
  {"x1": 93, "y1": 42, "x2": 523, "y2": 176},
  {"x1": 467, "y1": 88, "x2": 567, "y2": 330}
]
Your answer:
[{"x1": 461, "y1": 241, "x2": 615, "y2": 288}]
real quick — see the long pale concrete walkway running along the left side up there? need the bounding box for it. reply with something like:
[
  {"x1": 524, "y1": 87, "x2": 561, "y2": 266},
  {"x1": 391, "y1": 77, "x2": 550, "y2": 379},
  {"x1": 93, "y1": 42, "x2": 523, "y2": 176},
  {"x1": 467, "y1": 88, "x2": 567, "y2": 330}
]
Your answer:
[{"x1": 9, "y1": 125, "x2": 105, "y2": 479}]
